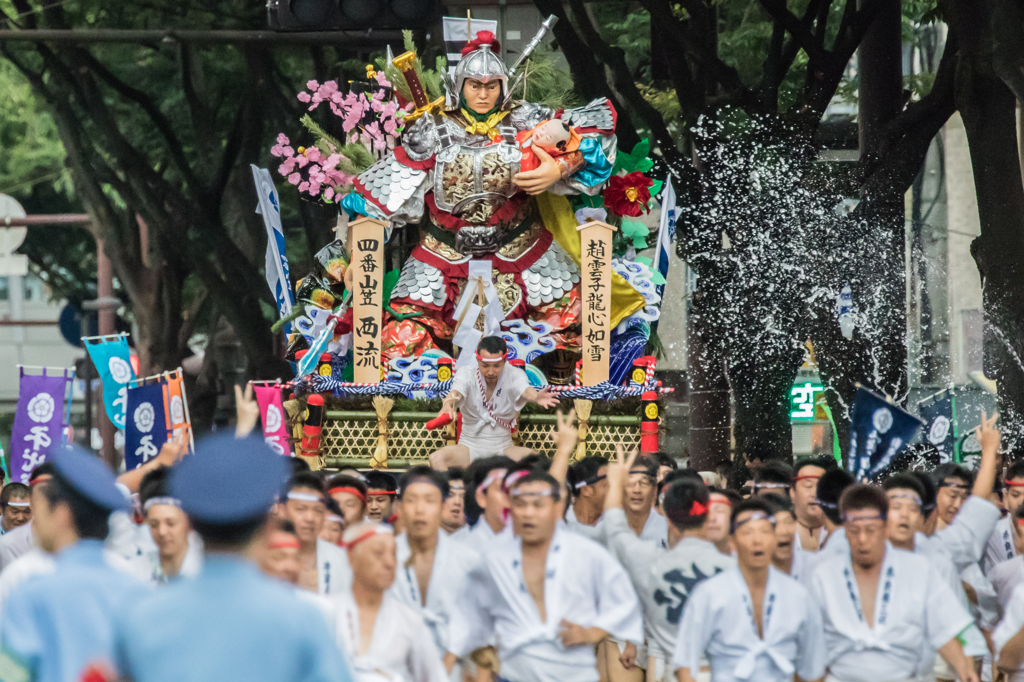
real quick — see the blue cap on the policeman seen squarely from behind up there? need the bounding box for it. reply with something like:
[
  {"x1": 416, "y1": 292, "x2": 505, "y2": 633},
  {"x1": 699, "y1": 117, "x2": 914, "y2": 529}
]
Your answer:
[{"x1": 169, "y1": 435, "x2": 291, "y2": 525}]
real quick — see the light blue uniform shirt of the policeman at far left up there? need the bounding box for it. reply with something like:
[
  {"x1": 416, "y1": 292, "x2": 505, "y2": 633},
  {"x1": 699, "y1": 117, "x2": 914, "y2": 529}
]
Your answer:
[{"x1": 0, "y1": 540, "x2": 148, "y2": 682}]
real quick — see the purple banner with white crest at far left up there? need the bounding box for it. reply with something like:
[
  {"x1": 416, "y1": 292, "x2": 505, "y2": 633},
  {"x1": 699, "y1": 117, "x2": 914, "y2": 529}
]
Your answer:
[{"x1": 10, "y1": 368, "x2": 70, "y2": 484}]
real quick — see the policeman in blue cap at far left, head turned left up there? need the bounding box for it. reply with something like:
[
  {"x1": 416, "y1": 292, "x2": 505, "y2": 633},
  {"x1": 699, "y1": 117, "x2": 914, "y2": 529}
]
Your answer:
[{"x1": 0, "y1": 440, "x2": 146, "y2": 682}]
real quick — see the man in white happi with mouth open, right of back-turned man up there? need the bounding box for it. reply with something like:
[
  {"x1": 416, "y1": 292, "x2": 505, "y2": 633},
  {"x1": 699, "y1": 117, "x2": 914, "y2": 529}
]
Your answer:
[{"x1": 672, "y1": 498, "x2": 825, "y2": 682}]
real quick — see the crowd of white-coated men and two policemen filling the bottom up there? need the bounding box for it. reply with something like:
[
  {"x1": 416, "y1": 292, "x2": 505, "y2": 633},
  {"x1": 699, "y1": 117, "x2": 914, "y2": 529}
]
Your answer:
[{"x1": 0, "y1": 339, "x2": 1024, "y2": 682}]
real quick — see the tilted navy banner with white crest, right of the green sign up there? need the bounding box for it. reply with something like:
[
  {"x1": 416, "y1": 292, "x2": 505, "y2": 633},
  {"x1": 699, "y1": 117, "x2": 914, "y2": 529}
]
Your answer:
[{"x1": 849, "y1": 386, "x2": 925, "y2": 480}]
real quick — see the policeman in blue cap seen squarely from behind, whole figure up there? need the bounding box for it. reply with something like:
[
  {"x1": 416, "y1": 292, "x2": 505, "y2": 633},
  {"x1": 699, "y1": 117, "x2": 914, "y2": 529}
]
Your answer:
[{"x1": 117, "y1": 436, "x2": 352, "y2": 682}]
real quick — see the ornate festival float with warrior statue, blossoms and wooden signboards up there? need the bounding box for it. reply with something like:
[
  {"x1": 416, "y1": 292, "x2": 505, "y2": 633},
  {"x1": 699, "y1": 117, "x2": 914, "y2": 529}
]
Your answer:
[{"x1": 253, "y1": 21, "x2": 670, "y2": 469}]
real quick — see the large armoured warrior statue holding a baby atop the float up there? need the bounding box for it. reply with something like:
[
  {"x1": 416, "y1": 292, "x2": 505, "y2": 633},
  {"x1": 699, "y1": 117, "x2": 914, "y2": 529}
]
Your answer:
[{"x1": 348, "y1": 27, "x2": 615, "y2": 366}]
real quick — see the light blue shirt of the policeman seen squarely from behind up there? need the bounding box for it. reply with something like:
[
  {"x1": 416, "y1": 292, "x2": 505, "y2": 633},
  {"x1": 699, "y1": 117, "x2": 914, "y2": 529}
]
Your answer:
[{"x1": 118, "y1": 553, "x2": 352, "y2": 682}]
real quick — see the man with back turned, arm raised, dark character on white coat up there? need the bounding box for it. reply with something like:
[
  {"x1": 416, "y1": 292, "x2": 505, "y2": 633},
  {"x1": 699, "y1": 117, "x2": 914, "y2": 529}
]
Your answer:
[{"x1": 604, "y1": 447, "x2": 736, "y2": 681}]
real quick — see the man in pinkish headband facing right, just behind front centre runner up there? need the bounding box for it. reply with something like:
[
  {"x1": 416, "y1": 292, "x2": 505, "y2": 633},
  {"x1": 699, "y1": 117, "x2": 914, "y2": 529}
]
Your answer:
[{"x1": 452, "y1": 455, "x2": 515, "y2": 550}]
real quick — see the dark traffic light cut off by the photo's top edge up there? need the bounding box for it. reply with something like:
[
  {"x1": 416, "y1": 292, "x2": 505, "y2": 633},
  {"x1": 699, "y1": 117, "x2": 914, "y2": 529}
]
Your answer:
[{"x1": 266, "y1": 0, "x2": 442, "y2": 31}]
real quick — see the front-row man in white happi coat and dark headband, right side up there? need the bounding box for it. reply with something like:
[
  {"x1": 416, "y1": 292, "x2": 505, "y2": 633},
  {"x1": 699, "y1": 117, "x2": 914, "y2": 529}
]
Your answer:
[{"x1": 810, "y1": 484, "x2": 978, "y2": 682}]
